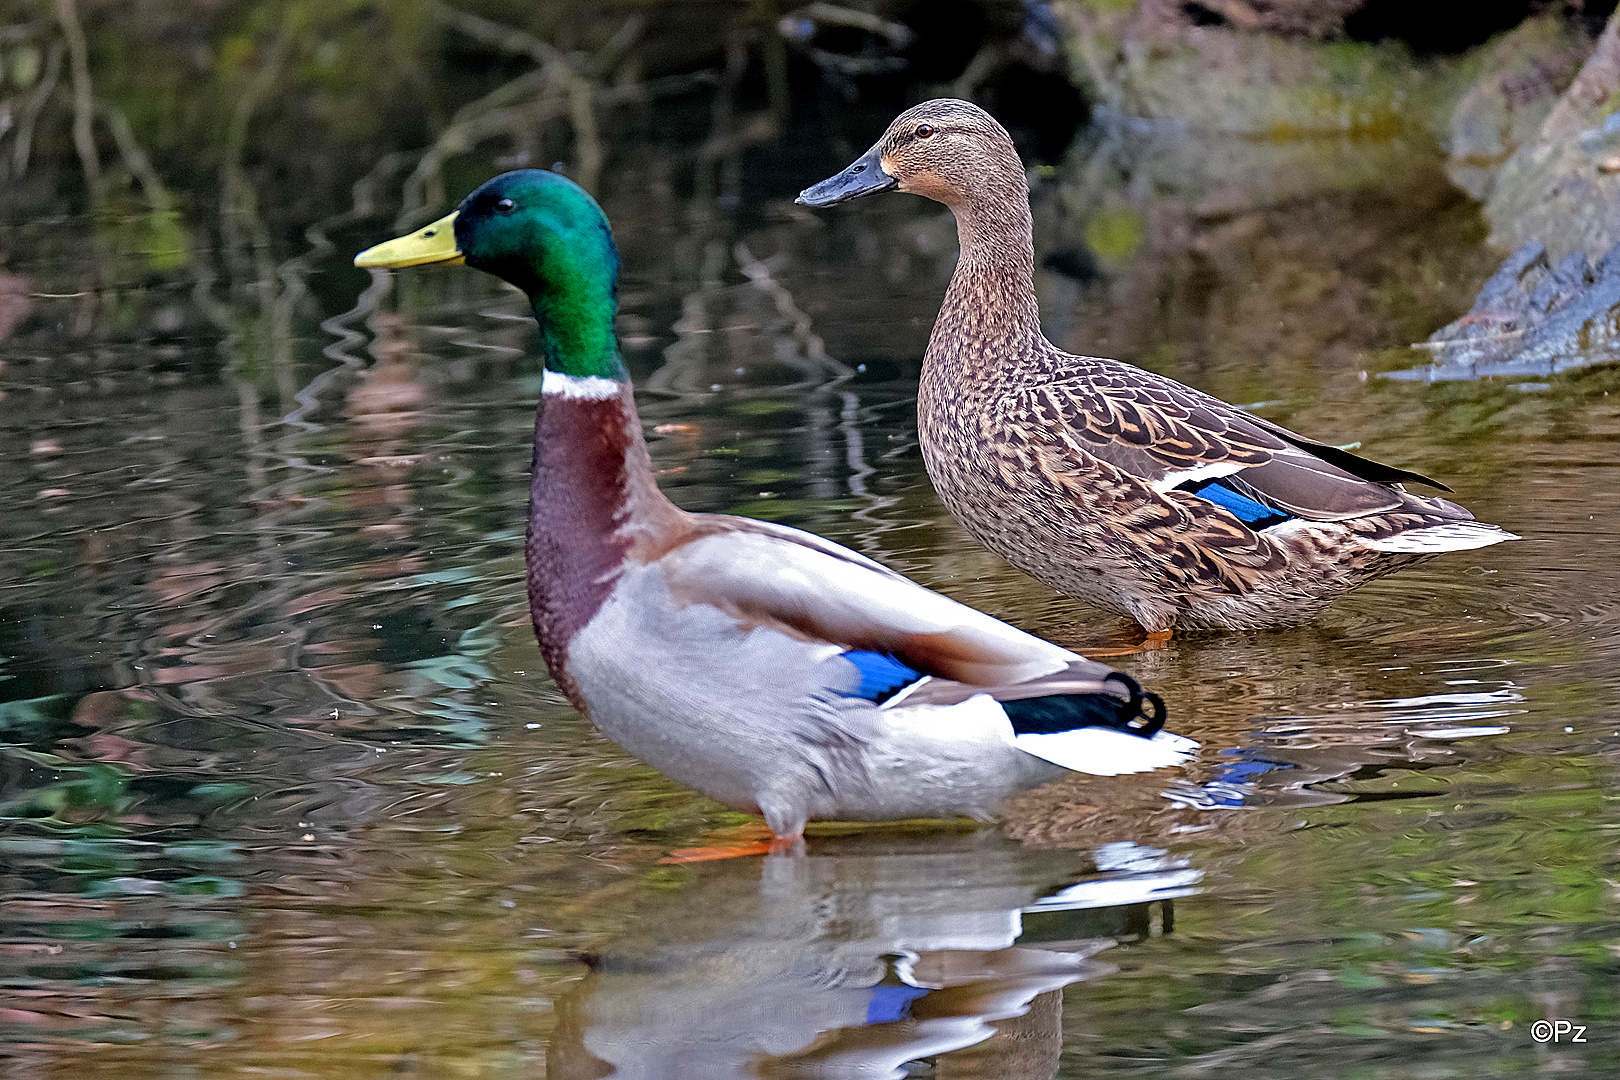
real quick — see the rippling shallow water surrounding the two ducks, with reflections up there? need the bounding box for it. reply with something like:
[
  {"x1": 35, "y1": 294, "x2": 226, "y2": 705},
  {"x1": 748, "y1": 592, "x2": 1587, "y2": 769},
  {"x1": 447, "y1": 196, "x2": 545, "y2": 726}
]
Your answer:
[{"x1": 0, "y1": 122, "x2": 1620, "y2": 1080}]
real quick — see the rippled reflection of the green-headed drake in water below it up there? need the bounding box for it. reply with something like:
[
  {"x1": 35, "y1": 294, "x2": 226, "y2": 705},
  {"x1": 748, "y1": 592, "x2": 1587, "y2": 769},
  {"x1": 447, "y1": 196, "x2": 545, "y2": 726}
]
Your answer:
[{"x1": 548, "y1": 831, "x2": 1202, "y2": 1080}]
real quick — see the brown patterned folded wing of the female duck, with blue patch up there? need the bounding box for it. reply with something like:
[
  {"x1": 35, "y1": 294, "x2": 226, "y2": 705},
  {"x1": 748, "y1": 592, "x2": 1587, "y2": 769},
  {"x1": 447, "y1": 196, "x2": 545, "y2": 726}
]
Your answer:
[{"x1": 1030, "y1": 356, "x2": 1473, "y2": 528}]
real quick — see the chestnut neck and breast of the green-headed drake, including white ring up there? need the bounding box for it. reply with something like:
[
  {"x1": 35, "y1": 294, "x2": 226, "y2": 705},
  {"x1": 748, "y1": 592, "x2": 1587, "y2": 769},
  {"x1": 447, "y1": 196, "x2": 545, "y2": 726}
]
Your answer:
[{"x1": 525, "y1": 303, "x2": 685, "y2": 704}]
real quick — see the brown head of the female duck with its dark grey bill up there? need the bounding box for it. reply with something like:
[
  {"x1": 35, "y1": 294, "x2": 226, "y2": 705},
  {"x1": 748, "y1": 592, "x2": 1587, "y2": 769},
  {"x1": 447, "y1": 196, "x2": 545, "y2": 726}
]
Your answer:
[{"x1": 795, "y1": 97, "x2": 1024, "y2": 207}]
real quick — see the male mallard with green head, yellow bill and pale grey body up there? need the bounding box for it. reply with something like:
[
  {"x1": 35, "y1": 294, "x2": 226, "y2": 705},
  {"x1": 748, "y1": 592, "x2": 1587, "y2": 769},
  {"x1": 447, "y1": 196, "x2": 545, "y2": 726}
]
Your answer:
[{"x1": 355, "y1": 170, "x2": 1194, "y2": 844}]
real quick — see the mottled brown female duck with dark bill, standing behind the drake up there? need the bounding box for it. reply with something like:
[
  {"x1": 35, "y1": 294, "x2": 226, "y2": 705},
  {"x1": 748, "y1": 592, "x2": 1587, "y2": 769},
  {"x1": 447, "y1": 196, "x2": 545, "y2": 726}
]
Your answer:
[{"x1": 799, "y1": 99, "x2": 1518, "y2": 636}]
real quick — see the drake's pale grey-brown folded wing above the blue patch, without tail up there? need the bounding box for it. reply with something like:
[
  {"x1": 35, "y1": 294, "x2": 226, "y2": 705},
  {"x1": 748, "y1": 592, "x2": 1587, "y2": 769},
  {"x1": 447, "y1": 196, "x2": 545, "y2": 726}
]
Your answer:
[{"x1": 658, "y1": 515, "x2": 1118, "y2": 696}]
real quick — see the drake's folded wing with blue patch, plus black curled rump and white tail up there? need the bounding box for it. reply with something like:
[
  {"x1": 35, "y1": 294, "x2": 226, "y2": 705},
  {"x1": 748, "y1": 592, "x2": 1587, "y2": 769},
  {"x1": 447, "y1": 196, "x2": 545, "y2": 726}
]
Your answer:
[{"x1": 658, "y1": 517, "x2": 1197, "y2": 776}]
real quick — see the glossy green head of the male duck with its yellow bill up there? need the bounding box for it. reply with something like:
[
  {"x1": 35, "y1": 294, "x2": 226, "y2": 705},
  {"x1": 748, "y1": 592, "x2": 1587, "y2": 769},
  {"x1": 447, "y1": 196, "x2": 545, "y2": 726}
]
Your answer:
[{"x1": 355, "y1": 168, "x2": 625, "y2": 379}]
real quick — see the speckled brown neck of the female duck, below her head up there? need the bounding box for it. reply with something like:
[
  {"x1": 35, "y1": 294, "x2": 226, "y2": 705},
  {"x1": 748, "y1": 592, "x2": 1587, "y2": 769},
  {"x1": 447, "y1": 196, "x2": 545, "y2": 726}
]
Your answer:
[{"x1": 923, "y1": 168, "x2": 1043, "y2": 393}]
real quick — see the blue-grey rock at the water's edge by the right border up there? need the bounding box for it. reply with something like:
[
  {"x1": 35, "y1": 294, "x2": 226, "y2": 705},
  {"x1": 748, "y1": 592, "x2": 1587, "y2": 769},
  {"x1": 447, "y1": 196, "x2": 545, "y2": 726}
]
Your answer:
[{"x1": 1385, "y1": 241, "x2": 1620, "y2": 382}]
